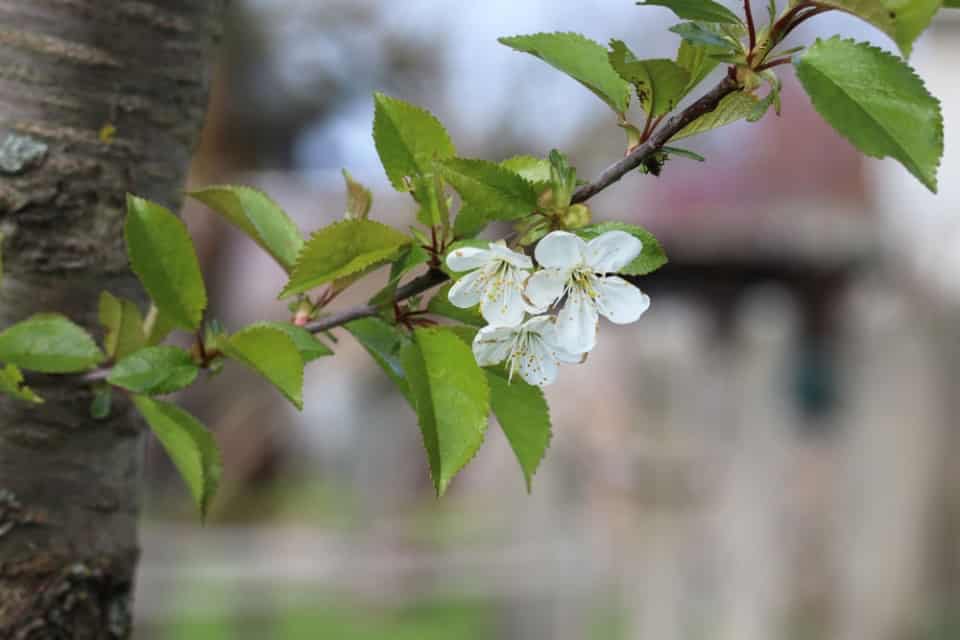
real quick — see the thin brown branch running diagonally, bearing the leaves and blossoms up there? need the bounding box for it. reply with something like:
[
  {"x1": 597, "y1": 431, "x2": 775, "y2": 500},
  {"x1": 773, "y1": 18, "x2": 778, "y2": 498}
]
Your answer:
[{"x1": 81, "y1": 72, "x2": 740, "y2": 383}]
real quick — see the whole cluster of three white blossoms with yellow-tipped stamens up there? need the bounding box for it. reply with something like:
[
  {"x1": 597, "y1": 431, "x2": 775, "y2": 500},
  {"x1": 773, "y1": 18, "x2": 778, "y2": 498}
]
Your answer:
[{"x1": 447, "y1": 231, "x2": 650, "y2": 386}]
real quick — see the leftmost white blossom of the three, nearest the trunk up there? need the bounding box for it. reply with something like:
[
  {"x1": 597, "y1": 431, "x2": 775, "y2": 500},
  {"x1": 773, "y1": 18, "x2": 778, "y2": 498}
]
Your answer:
[{"x1": 447, "y1": 241, "x2": 536, "y2": 326}]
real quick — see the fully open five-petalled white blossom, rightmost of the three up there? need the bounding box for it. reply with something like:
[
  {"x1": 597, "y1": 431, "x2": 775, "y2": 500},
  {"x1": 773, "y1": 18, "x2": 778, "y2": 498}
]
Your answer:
[{"x1": 524, "y1": 231, "x2": 650, "y2": 353}]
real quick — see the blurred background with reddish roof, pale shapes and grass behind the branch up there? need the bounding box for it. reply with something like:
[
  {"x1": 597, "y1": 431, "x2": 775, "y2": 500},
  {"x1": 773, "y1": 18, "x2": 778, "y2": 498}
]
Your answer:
[{"x1": 131, "y1": 0, "x2": 960, "y2": 640}]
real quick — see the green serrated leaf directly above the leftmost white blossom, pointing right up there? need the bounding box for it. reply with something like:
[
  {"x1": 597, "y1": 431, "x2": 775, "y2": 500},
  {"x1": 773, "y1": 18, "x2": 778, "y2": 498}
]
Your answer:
[{"x1": 438, "y1": 158, "x2": 537, "y2": 220}]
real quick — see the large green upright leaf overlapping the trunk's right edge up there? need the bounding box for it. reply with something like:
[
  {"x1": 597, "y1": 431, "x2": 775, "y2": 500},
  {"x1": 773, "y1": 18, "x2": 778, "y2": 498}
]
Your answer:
[{"x1": 124, "y1": 195, "x2": 207, "y2": 331}]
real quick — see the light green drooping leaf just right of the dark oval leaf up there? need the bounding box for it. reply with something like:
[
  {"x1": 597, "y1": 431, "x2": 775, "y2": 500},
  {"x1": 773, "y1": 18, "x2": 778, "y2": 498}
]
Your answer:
[{"x1": 221, "y1": 323, "x2": 303, "y2": 409}]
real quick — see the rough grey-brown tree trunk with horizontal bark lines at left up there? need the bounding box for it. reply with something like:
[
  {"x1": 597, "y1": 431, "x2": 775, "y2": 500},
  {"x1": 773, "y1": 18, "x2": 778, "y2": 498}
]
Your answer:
[{"x1": 0, "y1": 0, "x2": 225, "y2": 640}]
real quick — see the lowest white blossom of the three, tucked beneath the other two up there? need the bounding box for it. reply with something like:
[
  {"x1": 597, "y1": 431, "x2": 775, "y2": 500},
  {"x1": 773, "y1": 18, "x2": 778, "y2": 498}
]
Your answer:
[{"x1": 473, "y1": 316, "x2": 585, "y2": 387}]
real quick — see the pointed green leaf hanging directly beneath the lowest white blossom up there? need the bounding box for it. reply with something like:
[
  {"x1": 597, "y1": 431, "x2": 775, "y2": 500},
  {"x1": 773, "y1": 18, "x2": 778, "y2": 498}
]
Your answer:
[{"x1": 486, "y1": 369, "x2": 550, "y2": 491}]
